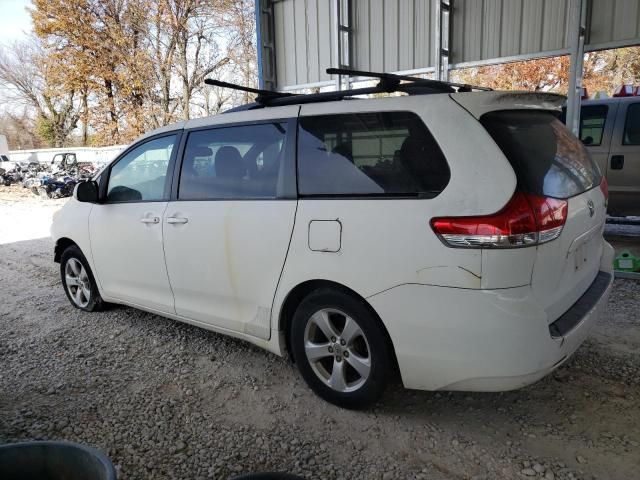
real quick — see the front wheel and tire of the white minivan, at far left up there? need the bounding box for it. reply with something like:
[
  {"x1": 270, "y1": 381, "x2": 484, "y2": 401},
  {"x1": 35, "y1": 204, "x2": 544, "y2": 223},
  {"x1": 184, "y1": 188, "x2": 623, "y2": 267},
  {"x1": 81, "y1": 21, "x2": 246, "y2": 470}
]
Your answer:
[{"x1": 60, "y1": 245, "x2": 104, "y2": 312}]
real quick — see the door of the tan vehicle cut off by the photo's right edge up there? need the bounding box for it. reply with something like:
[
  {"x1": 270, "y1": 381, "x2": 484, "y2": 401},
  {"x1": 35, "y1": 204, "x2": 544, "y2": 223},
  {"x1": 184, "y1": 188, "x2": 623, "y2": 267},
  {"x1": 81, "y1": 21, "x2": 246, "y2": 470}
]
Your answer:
[{"x1": 607, "y1": 102, "x2": 640, "y2": 215}]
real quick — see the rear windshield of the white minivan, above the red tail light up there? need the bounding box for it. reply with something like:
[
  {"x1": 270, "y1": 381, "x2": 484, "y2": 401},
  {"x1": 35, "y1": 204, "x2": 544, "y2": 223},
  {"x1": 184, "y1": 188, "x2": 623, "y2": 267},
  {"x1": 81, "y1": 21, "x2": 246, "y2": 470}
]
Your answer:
[{"x1": 480, "y1": 110, "x2": 602, "y2": 198}]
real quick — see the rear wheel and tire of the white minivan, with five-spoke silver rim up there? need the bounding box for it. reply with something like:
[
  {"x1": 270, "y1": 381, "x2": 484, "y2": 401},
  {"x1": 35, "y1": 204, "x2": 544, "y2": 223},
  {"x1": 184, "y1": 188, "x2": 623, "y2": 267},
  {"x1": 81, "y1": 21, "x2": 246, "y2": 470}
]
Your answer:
[{"x1": 290, "y1": 288, "x2": 392, "y2": 409}]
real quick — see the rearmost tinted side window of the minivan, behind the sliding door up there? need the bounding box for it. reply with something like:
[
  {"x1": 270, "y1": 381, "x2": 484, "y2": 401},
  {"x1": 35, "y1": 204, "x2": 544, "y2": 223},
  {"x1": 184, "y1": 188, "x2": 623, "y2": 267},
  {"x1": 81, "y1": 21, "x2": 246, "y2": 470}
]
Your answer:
[{"x1": 298, "y1": 112, "x2": 450, "y2": 197}]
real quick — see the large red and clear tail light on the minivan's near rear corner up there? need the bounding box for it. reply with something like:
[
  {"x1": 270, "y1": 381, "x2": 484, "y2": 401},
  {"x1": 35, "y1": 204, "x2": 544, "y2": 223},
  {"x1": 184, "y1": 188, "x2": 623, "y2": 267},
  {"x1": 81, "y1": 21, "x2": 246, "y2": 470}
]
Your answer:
[{"x1": 431, "y1": 192, "x2": 567, "y2": 248}]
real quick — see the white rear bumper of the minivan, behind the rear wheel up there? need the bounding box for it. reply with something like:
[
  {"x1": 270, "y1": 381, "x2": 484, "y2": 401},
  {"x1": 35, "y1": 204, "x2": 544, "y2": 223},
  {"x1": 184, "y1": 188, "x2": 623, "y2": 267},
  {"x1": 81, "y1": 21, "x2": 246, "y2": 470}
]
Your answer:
[{"x1": 368, "y1": 245, "x2": 613, "y2": 391}]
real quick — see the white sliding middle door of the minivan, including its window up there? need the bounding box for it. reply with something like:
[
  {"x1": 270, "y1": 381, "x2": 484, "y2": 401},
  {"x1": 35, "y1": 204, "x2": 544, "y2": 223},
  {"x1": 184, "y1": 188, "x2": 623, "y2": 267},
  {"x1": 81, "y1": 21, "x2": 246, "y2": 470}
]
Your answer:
[{"x1": 164, "y1": 120, "x2": 296, "y2": 339}]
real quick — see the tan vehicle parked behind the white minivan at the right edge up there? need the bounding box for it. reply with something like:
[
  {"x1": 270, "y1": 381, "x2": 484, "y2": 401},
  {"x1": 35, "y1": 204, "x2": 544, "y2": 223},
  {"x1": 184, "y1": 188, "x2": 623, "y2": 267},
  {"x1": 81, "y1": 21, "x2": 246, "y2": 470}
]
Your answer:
[{"x1": 564, "y1": 96, "x2": 640, "y2": 216}]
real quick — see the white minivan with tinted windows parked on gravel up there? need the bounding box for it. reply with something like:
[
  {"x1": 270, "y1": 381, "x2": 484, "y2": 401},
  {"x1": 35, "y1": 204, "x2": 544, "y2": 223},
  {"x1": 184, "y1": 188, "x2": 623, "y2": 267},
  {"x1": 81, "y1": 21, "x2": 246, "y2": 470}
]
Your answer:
[{"x1": 52, "y1": 79, "x2": 613, "y2": 408}]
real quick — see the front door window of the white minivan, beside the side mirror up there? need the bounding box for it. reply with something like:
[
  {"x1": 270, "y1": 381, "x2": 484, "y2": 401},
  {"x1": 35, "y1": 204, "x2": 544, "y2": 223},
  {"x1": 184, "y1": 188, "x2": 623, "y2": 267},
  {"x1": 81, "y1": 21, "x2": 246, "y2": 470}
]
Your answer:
[{"x1": 107, "y1": 135, "x2": 176, "y2": 202}]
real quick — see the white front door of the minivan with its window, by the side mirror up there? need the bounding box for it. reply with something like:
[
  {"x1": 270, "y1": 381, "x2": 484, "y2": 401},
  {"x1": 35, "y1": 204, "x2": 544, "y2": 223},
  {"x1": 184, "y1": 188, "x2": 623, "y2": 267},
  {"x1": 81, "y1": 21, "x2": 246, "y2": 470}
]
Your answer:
[{"x1": 89, "y1": 134, "x2": 179, "y2": 313}]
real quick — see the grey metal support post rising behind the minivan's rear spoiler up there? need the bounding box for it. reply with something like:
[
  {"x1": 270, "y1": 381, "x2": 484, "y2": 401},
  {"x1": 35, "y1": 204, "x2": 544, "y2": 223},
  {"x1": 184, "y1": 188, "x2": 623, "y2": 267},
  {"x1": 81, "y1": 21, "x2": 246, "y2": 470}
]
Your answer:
[{"x1": 566, "y1": 0, "x2": 587, "y2": 136}]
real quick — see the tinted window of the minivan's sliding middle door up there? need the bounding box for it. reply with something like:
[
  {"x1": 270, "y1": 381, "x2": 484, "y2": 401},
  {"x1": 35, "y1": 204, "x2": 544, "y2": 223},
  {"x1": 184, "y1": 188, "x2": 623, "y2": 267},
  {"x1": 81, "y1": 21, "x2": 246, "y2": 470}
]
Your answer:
[{"x1": 178, "y1": 123, "x2": 286, "y2": 200}]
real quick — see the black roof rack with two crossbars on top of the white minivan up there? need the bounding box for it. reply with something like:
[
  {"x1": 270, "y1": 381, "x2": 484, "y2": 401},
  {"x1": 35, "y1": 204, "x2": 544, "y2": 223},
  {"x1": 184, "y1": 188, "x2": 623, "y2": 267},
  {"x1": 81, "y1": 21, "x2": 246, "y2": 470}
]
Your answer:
[{"x1": 205, "y1": 68, "x2": 491, "y2": 113}]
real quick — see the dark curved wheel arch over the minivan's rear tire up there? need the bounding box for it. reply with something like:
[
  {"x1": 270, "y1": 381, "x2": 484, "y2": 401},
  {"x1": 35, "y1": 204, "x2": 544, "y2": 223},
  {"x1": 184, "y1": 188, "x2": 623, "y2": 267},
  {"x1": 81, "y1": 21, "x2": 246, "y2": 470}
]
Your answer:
[{"x1": 278, "y1": 279, "x2": 398, "y2": 372}]
